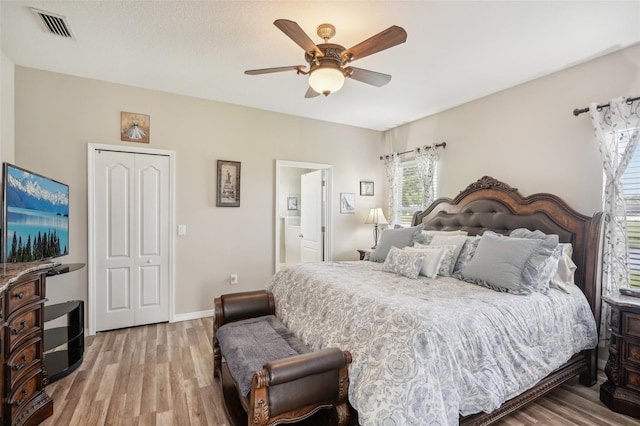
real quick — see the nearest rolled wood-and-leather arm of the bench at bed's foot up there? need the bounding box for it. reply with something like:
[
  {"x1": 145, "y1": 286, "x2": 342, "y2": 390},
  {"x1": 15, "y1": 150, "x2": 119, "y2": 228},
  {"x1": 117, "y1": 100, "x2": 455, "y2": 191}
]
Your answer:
[{"x1": 247, "y1": 348, "x2": 351, "y2": 425}]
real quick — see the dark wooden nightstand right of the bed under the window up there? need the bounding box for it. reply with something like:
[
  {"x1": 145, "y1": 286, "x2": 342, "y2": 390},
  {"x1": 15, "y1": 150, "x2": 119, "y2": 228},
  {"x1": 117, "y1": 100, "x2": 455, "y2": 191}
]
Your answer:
[{"x1": 600, "y1": 294, "x2": 640, "y2": 418}]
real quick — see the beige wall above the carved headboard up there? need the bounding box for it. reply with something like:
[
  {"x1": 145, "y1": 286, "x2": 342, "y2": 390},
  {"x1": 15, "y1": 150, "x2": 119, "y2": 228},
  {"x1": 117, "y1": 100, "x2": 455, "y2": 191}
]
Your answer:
[{"x1": 382, "y1": 45, "x2": 640, "y2": 215}]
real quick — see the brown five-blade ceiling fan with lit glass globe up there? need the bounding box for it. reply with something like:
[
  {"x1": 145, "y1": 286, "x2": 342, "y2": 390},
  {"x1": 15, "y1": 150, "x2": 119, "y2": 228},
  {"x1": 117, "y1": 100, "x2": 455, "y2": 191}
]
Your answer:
[{"x1": 244, "y1": 19, "x2": 407, "y2": 98}]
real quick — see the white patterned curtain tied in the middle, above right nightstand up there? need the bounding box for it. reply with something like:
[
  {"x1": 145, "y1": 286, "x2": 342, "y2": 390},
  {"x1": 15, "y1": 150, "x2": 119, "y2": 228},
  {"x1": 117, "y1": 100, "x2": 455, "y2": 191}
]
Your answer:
[{"x1": 589, "y1": 98, "x2": 640, "y2": 296}]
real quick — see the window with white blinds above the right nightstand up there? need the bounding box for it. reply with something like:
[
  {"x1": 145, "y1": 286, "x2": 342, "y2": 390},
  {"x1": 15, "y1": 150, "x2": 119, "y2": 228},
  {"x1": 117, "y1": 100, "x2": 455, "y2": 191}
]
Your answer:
[{"x1": 615, "y1": 129, "x2": 640, "y2": 287}]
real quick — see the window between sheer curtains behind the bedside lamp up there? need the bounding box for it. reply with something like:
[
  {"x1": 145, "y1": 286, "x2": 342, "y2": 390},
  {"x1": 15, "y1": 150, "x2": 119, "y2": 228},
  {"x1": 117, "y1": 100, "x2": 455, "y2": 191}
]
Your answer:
[{"x1": 396, "y1": 160, "x2": 438, "y2": 226}]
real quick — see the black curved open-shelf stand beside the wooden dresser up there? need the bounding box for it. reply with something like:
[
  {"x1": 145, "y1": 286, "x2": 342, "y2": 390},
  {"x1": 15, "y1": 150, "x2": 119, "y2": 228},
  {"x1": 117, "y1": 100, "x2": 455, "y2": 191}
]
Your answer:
[{"x1": 43, "y1": 263, "x2": 85, "y2": 385}]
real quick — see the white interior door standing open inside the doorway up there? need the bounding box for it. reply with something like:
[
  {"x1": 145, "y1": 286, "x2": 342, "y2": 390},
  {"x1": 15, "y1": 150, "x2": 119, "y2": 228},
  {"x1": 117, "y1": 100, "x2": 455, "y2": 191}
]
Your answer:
[{"x1": 300, "y1": 170, "x2": 324, "y2": 262}]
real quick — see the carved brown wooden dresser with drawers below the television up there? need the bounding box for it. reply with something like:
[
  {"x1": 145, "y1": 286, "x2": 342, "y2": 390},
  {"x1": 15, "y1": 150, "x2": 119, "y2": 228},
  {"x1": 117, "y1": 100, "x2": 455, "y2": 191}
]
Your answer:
[{"x1": 0, "y1": 262, "x2": 53, "y2": 425}]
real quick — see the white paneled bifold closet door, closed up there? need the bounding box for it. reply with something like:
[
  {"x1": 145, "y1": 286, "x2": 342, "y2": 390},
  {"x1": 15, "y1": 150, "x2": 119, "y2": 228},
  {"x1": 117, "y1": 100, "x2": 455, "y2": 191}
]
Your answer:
[{"x1": 94, "y1": 150, "x2": 170, "y2": 331}]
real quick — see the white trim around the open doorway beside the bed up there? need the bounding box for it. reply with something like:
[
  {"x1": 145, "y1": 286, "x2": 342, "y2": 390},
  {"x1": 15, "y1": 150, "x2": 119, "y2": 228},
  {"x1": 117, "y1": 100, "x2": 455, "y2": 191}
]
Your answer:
[{"x1": 274, "y1": 160, "x2": 333, "y2": 272}]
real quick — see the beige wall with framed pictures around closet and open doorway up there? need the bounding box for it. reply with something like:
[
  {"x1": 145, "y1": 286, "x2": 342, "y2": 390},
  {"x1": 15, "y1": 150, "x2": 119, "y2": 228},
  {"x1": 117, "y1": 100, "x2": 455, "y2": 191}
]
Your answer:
[{"x1": 15, "y1": 66, "x2": 382, "y2": 314}]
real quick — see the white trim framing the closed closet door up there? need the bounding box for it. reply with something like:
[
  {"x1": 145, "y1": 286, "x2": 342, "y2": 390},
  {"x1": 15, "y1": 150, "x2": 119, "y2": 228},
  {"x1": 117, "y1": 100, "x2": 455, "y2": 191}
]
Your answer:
[{"x1": 87, "y1": 143, "x2": 176, "y2": 336}]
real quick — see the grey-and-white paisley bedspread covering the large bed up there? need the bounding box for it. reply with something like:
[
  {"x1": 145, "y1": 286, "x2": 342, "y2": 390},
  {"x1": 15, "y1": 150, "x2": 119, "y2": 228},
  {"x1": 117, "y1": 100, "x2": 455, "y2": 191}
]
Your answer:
[{"x1": 267, "y1": 262, "x2": 597, "y2": 426}]
